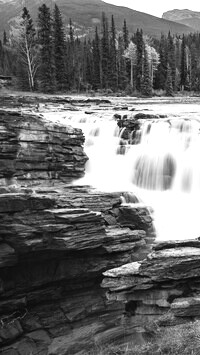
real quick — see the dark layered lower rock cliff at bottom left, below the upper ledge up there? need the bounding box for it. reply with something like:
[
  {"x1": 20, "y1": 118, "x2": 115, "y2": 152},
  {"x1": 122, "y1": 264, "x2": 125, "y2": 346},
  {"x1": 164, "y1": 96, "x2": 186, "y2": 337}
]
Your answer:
[{"x1": 0, "y1": 184, "x2": 153, "y2": 355}]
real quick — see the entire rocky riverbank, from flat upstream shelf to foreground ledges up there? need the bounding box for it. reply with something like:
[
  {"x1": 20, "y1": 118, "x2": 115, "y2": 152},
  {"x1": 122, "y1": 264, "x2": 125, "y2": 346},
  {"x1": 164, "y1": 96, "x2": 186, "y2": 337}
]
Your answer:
[{"x1": 0, "y1": 96, "x2": 200, "y2": 355}]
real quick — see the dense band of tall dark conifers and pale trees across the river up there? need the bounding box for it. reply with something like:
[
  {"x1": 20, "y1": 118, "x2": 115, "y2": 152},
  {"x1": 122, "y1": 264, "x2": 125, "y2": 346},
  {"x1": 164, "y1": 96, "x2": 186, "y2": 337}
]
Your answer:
[{"x1": 0, "y1": 4, "x2": 200, "y2": 96}]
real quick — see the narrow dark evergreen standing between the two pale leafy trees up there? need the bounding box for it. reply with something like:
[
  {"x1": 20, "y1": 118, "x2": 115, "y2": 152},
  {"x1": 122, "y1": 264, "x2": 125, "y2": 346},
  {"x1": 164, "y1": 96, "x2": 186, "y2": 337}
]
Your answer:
[{"x1": 136, "y1": 30, "x2": 144, "y2": 92}]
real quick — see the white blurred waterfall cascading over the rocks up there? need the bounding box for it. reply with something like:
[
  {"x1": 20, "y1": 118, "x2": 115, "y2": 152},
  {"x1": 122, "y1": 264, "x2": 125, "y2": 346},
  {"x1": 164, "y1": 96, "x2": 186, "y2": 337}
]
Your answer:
[{"x1": 45, "y1": 100, "x2": 200, "y2": 240}]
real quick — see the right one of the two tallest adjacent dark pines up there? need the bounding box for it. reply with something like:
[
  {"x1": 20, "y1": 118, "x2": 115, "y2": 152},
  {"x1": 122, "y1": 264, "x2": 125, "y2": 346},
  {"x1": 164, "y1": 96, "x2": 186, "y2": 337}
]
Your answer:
[{"x1": 53, "y1": 4, "x2": 67, "y2": 90}]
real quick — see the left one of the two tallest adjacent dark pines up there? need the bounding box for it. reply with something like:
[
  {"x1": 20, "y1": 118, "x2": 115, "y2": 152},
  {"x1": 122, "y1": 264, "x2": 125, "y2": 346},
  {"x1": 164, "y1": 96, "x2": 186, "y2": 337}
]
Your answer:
[{"x1": 38, "y1": 4, "x2": 55, "y2": 92}]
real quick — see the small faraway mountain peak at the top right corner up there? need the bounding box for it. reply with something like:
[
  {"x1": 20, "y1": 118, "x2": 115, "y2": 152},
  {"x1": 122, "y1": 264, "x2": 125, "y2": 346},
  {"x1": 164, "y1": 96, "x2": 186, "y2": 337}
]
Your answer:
[{"x1": 162, "y1": 9, "x2": 200, "y2": 31}]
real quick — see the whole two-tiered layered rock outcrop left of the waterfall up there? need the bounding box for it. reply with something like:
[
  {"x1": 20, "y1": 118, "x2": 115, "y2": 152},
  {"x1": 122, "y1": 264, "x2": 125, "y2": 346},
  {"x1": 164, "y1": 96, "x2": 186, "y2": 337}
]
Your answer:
[{"x1": 0, "y1": 110, "x2": 152, "y2": 355}]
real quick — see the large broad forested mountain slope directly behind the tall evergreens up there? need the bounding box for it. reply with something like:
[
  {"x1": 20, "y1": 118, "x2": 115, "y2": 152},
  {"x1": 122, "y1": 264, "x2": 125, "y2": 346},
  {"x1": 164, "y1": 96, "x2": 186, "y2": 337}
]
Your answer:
[{"x1": 0, "y1": 0, "x2": 194, "y2": 37}]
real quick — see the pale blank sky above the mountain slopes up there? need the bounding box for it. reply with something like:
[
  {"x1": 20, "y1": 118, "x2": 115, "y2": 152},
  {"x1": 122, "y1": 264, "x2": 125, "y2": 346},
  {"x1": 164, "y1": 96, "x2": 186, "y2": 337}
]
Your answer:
[{"x1": 103, "y1": 0, "x2": 200, "y2": 17}]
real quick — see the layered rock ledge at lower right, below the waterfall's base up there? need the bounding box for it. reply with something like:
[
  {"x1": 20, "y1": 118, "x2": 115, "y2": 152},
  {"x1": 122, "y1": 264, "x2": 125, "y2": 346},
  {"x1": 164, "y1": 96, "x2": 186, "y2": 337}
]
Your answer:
[{"x1": 102, "y1": 240, "x2": 200, "y2": 333}]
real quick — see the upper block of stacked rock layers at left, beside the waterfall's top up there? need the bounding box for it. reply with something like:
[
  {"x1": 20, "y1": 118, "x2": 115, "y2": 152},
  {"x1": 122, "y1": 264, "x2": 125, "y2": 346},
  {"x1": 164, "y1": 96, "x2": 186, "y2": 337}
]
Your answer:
[{"x1": 0, "y1": 110, "x2": 87, "y2": 185}]
